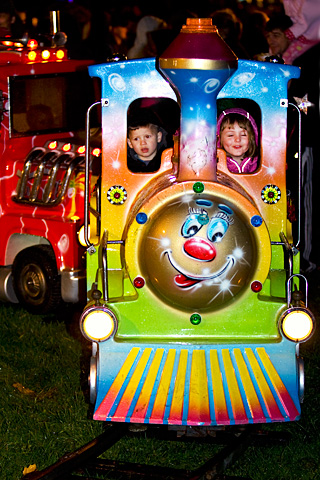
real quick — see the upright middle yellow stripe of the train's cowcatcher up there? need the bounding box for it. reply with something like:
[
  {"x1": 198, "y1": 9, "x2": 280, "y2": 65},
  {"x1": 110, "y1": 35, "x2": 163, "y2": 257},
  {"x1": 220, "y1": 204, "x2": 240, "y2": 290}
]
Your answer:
[{"x1": 188, "y1": 350, "x2": 210, "y2": 422}]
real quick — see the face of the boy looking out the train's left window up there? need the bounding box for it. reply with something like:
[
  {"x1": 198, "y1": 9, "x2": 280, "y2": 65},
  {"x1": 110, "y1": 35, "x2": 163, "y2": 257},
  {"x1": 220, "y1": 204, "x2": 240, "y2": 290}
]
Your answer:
[{"x1": 128, "y1": 127, "x2": 162, "y2": 161}]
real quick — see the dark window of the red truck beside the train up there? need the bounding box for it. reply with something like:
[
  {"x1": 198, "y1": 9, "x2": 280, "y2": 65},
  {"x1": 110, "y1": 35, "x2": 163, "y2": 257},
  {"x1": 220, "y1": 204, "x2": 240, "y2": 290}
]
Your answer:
[{"x1": 9, "y1": 70, "x2": 100, "y2": 137}]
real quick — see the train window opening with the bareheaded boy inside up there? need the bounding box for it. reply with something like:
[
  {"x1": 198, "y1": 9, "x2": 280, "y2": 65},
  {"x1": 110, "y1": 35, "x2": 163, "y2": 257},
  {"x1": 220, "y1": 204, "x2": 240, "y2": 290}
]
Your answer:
[{"x1": 127, "y1": 98, "x2": 180, "y2": 173}]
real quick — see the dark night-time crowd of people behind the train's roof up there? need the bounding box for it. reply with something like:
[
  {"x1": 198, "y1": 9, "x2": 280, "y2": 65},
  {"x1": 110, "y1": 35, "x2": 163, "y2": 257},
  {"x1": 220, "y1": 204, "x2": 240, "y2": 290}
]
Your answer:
[{"x1": 0, "y1": 0, "x2": 320, "y2": 63}]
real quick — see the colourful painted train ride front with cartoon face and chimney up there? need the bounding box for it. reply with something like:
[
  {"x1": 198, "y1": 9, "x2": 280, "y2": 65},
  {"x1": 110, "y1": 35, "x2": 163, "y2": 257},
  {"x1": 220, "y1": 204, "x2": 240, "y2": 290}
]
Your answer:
[{"x1": 81, "y1": 19, "x2": 314, "y2": 428}]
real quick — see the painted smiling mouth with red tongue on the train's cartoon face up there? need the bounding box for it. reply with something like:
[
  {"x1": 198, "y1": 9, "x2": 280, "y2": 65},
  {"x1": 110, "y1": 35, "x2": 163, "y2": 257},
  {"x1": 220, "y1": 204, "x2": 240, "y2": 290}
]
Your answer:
[{"x1": 162, "y1": 250, "x2": 236, "y2": 288}]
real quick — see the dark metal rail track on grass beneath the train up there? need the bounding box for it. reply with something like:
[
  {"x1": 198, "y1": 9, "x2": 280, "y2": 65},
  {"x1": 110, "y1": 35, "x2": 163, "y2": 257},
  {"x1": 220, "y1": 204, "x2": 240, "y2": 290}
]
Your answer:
[{"x1": 23, "y1": 424, "x2": 289, "y2": 480}]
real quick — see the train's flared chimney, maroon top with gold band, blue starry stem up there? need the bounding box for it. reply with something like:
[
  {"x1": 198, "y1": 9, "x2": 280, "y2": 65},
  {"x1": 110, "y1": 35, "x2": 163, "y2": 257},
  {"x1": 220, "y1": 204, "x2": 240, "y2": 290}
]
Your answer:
[{"x1": 159, "y1": 18, "x2": 238, "y2": 180}]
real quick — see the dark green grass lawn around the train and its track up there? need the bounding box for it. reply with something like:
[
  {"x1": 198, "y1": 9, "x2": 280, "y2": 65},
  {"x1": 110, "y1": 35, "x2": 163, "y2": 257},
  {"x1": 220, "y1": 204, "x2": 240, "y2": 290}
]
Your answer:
[{"x1": 0, "y1": 289, "x2": 320, "y2": 480}]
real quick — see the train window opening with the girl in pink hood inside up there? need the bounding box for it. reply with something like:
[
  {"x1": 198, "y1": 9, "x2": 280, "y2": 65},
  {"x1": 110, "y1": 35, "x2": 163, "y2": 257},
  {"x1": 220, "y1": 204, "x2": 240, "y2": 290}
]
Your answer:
[{"x1": 217, "y1": 98, "x2": 261, "y2": 173}]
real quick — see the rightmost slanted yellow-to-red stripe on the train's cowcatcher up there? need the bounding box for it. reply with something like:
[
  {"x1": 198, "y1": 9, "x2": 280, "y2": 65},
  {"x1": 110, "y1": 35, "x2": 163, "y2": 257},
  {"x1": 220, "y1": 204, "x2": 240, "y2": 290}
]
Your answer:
[{"x1": 257, "y1": 347, "x2": 300, "y2": 420}]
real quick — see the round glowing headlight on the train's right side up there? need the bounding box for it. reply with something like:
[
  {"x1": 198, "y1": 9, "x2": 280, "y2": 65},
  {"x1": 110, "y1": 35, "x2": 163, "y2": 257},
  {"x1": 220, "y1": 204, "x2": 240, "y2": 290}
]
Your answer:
[{"x1": 281, "y1": 308, "x2": 315, "y2": 342}]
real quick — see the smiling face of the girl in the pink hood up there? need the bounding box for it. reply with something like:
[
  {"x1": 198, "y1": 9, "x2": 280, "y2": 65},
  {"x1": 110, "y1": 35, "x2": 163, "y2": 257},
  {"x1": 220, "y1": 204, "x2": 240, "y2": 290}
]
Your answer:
[{"x1": 220, "y1": 122, "x2": 249, "y2": 162}]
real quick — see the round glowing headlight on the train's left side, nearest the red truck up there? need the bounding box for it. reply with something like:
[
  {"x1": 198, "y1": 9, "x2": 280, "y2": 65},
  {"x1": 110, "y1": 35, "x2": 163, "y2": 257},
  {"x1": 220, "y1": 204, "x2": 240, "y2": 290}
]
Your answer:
[{"x1": 80, "y1": 307, "x2": 117, "y2": 342}]
